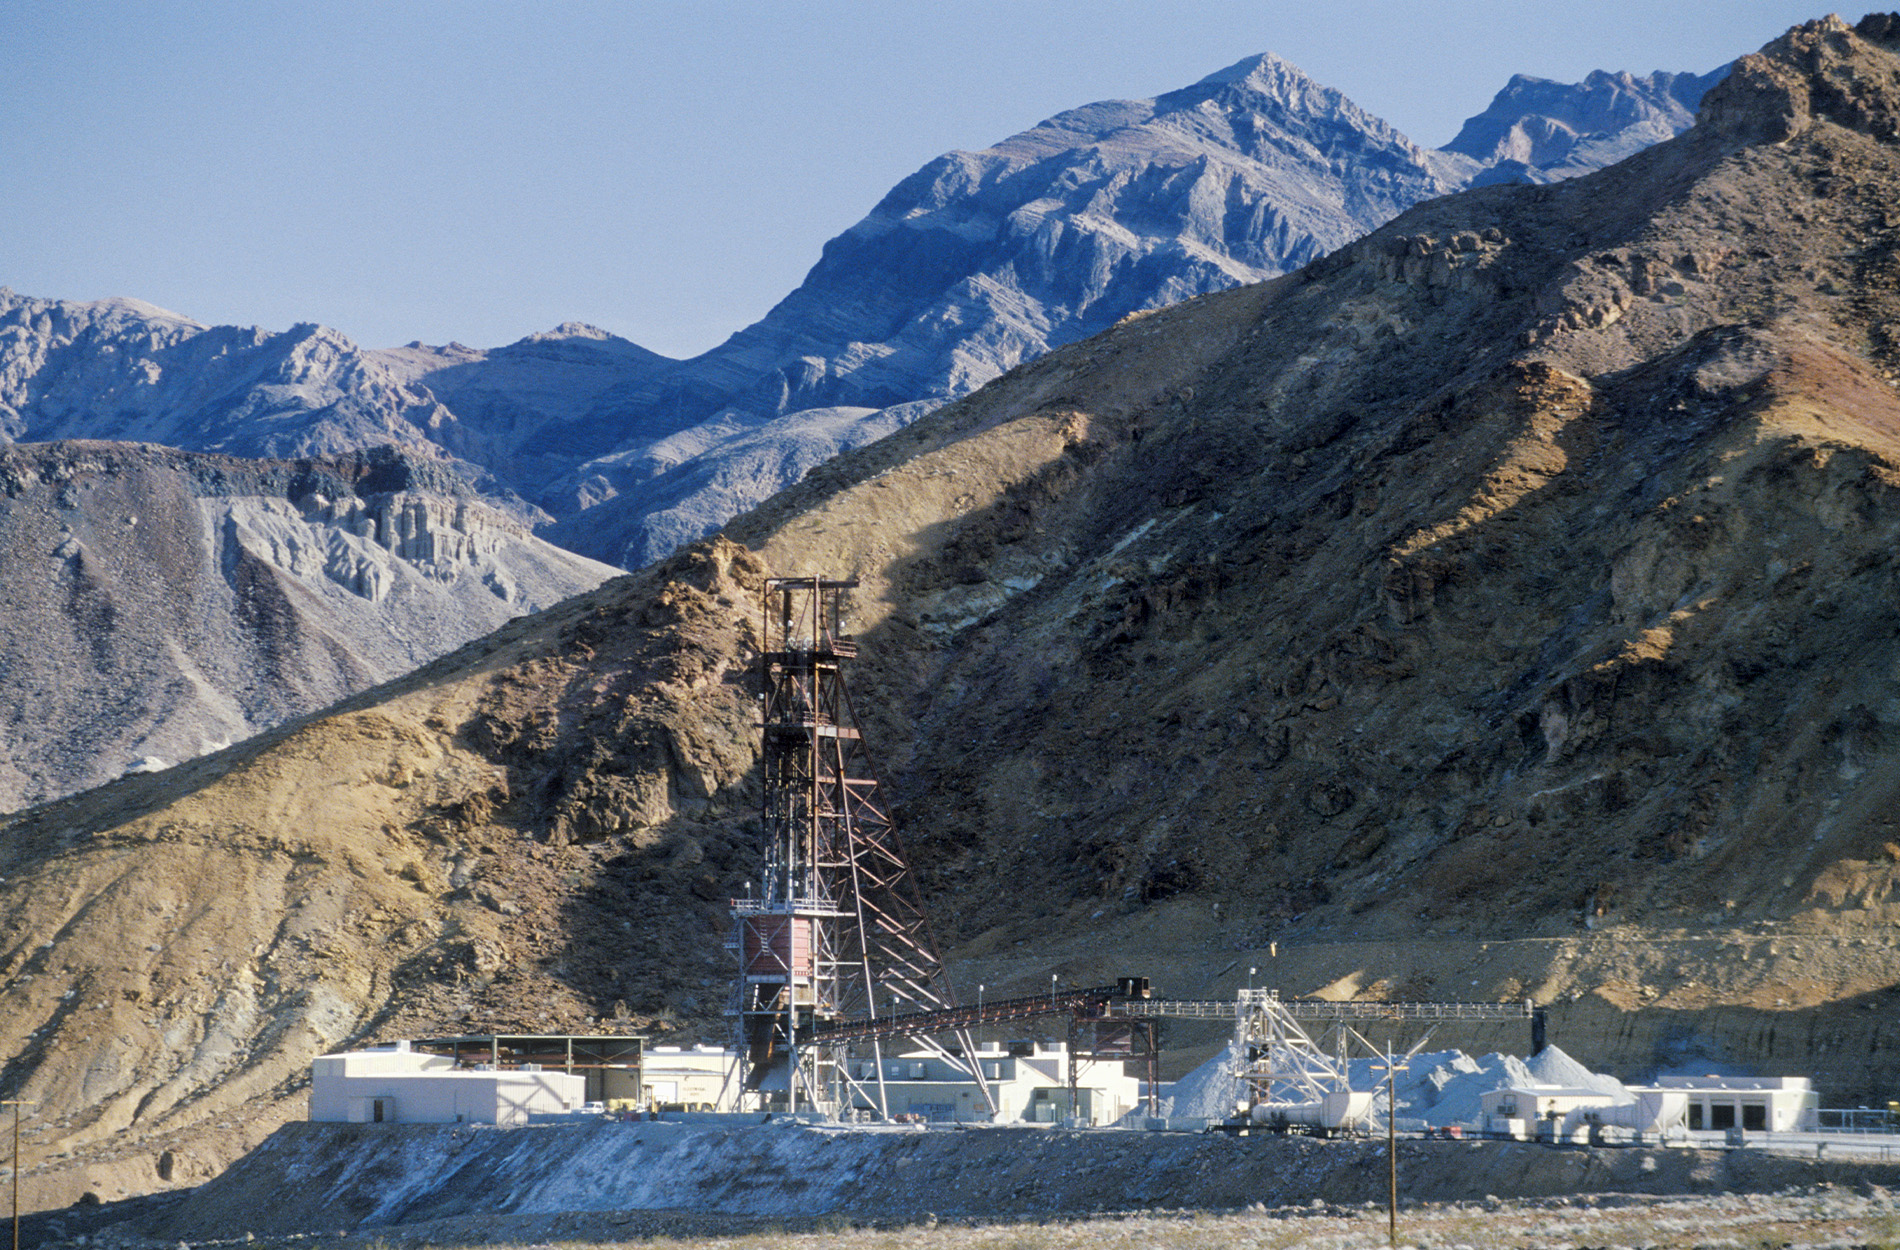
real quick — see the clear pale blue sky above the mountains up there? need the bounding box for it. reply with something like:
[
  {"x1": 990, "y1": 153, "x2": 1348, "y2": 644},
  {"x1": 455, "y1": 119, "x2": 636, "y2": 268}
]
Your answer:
[{"x1": 0, "y1": 0, "x2": 1839, "y2": 355}]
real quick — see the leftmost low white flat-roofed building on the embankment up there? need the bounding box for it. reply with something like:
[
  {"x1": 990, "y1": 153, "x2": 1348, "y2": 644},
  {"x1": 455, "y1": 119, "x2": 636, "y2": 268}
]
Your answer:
[{"x1": 310, "y1": 1041, "x2": 587, "y2": 1125}]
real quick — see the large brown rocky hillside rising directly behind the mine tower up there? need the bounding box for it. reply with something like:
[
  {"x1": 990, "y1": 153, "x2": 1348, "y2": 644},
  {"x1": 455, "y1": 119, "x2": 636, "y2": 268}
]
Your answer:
[{"x1": 11, "y1": 17, "x2": 1900, "y2": 1189}]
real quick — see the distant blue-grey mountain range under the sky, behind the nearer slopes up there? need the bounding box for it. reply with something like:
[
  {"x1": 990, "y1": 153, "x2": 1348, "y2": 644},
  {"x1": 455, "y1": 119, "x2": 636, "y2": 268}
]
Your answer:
[{"x1": 0, "y1": 53, "x2": 1720, "y2": 554}]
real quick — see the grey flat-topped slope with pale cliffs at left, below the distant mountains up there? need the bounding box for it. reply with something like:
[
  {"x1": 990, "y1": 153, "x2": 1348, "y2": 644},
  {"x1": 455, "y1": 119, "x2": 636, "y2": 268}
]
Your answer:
[{"x1": 0, "y1": 443, "x2": 614, "y2": 809}]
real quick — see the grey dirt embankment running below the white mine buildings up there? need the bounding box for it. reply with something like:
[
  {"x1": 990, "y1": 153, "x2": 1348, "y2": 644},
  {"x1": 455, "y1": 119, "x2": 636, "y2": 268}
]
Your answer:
[{"x1": 26, "y1": 1123, "x2": 1900, "y2": 1242}]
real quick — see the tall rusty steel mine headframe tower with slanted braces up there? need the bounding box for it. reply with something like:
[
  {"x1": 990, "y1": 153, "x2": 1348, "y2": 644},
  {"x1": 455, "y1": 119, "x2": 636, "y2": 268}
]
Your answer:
[{"x1": 728, "y1": 578, "x2": 994, "y2": 1109}]
